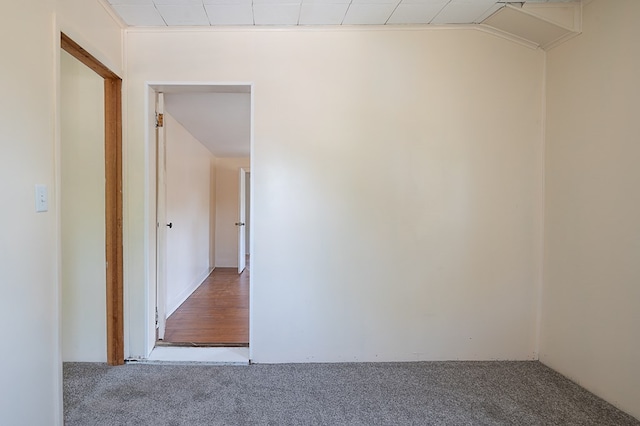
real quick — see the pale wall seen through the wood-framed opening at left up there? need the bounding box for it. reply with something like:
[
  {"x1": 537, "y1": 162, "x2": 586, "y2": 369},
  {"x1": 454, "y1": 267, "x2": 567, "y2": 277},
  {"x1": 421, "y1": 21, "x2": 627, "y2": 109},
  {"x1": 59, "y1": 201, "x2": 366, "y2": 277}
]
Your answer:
[{"x1": 60, "y1": 52, "x2": 107, "y2": 362}]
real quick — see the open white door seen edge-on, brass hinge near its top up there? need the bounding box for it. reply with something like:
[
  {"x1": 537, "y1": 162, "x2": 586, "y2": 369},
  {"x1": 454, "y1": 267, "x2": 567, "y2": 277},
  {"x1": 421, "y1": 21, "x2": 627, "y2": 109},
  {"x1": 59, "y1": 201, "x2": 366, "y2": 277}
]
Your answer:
[{"x1": 156, "y1": 93, "x2": 167, "y2": 340}]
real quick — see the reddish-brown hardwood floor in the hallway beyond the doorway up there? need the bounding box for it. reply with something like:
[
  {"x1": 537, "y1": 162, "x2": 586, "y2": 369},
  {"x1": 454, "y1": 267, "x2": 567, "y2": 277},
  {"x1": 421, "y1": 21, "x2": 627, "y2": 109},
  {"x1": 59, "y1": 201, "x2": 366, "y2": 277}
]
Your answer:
[{"x1": 162, "y1": 262, "x2": 249, "y2": 346}]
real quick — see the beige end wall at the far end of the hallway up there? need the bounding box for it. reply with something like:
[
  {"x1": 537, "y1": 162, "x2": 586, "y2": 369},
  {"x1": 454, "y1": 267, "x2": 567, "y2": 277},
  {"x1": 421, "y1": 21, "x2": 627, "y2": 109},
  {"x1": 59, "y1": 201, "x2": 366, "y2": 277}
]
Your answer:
[{"x1": 216, "y1": 158, "x2": 251, "y2": 268}]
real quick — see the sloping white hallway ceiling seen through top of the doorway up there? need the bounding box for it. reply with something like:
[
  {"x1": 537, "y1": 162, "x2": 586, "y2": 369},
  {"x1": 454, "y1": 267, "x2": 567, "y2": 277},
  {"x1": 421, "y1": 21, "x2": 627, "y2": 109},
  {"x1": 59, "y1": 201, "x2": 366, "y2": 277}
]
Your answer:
[{"x1": 164, "y1": 90, "x2": 251, "y2": 157}]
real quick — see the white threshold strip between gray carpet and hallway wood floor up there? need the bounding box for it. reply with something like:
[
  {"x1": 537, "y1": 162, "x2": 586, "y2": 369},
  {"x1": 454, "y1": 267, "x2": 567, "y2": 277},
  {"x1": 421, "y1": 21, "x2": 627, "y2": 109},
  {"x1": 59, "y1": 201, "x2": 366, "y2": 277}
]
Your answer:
[{"x1": 139, "y1": 346, "x2": 249, "y2": 365}]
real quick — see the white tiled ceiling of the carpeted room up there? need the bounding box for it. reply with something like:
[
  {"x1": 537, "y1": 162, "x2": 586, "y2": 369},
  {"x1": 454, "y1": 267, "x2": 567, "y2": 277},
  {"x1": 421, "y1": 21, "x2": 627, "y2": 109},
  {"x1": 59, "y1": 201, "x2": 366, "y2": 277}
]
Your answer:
[{"x1": 107, "y1": 0, "x2": 575, "y2": 27}]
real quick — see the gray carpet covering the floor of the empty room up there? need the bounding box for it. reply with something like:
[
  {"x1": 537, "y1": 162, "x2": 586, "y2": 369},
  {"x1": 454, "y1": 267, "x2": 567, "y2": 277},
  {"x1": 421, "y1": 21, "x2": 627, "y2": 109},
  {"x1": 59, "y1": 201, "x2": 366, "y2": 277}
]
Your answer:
[{"x1": 64, "y1": 362, "x2": 640, "y2": 426}]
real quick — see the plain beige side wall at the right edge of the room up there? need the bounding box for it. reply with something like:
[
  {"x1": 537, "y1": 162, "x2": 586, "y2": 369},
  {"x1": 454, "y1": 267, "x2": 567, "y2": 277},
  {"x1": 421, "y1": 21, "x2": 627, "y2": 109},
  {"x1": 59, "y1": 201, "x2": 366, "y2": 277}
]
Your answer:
[{"x1": 540, "y1": 0, "x2": 640, "y2": 418}]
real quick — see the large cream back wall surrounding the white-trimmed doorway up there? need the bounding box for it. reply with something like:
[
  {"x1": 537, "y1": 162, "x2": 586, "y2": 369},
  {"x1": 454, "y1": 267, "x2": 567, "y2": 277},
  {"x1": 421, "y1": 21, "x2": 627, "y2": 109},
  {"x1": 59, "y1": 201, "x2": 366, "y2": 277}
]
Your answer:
[{"x1": 126, "y1": 28, "x2": 544, "y2": 362}]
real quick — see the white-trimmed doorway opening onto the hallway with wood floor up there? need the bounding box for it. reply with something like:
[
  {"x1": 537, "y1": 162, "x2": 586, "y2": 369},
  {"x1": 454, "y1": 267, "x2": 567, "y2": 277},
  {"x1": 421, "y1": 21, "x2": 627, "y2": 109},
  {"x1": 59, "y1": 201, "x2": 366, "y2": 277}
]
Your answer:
[{"x1": 149, "y1": 83, "x2": 252, "y2": 358}]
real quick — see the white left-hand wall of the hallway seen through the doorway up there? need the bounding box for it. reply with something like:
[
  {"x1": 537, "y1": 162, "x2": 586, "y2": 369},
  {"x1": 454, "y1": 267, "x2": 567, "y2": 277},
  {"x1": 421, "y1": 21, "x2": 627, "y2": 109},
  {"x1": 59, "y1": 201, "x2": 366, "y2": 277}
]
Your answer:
[{"x1": 165, "y1": 113, "x2": 213, "y2": 315}]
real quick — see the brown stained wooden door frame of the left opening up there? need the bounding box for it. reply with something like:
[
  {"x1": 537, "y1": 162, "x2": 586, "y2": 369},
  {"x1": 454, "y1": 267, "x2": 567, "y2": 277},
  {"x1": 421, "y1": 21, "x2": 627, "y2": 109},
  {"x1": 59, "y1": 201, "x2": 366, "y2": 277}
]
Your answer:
[{"x1": 60, "y1": 32, "x2": 124, "y2": 365}]
